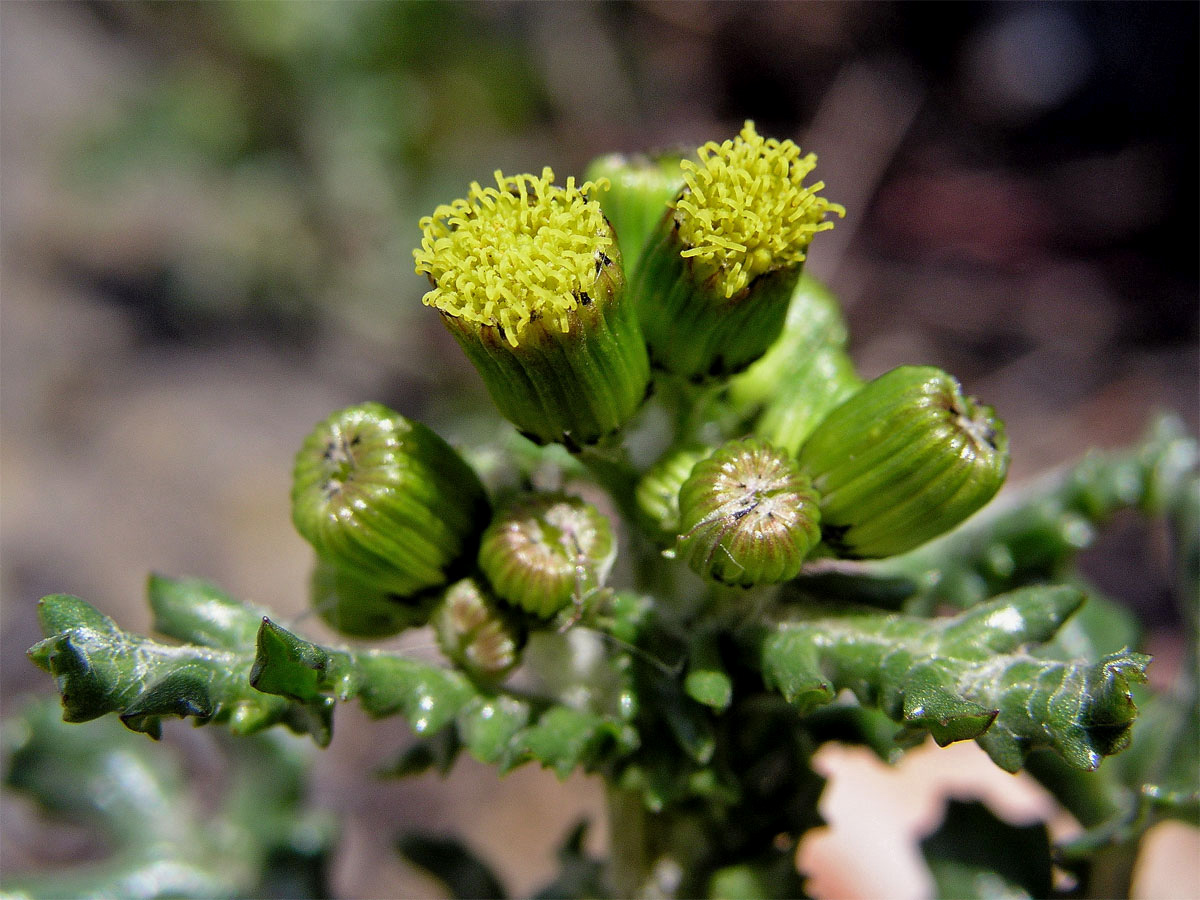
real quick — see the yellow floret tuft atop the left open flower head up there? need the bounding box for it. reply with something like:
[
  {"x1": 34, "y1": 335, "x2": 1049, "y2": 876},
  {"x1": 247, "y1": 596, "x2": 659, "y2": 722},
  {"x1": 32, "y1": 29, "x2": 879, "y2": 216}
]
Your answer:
[{"x1": 413, "y1": 168, "x2": 614, "y2": 347}]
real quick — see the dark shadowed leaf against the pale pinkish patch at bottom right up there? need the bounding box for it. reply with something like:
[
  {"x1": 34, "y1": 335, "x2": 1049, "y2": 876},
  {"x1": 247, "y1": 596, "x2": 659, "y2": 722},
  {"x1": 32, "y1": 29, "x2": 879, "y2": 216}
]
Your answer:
[{"x1": 920, "y1": 800, "x2": 1052, "y2": 900}]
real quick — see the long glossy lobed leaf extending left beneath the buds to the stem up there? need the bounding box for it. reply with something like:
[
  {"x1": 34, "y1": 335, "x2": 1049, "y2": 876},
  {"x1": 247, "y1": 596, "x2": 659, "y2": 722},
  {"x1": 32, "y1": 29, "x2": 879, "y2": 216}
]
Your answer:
[{"x1": 29, "y1": 576, "x2": 638, "y2": 778}]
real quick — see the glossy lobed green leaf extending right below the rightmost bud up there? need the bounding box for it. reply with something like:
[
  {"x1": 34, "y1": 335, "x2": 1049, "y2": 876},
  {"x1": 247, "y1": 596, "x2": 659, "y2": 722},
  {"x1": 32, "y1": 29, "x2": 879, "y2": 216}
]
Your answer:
[{"x1": 761, "y1": 587, "x2": 1150, "y2": 772}]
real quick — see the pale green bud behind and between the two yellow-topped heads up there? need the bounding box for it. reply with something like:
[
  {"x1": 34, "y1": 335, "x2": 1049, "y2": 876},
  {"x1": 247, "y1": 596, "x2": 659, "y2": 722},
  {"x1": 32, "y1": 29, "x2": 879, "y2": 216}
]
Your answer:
[{"x1": 583, "y1": 154, "x2": 683, "y2": 278}]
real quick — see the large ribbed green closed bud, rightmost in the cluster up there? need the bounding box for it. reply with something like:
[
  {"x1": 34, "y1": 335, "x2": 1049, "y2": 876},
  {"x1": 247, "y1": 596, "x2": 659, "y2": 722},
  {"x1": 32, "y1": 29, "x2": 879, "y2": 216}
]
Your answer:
[{"x1": 799, "y1": 366, "x2": 1008, "y2": 558}]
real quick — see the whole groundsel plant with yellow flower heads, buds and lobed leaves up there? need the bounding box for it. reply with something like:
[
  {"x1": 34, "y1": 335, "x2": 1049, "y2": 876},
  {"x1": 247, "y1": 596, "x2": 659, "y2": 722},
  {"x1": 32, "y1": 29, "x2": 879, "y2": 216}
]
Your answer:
[{"x1": 14, "y1": 122, "x2": 1200, "y2": 898}]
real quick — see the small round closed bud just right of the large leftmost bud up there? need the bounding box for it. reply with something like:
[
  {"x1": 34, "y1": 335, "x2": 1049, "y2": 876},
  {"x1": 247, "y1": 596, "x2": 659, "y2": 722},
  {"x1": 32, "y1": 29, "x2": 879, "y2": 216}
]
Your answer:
[{"x1": 479, "y1": 493, "x2": 617, "y2": 618}]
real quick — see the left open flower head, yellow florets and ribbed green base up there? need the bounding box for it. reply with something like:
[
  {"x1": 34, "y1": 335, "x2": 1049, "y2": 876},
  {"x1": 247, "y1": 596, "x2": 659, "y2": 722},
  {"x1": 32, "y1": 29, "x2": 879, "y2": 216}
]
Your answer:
[{"x1": 414, "y1": 169, "x2": 649, "y2": 449}]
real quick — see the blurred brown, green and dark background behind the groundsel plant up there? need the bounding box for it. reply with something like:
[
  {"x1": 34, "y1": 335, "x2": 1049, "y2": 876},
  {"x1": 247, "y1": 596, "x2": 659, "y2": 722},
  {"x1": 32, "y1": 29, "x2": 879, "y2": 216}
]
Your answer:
[{"x1": 0, "y1": 1, "x2": 1200, "y2": 896}]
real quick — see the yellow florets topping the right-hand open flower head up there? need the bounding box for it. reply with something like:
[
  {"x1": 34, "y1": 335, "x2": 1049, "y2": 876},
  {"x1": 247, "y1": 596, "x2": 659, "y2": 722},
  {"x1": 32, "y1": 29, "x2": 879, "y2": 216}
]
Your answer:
[{"x1": 674, "y1": 121, "x2": 846, "y2": 298}]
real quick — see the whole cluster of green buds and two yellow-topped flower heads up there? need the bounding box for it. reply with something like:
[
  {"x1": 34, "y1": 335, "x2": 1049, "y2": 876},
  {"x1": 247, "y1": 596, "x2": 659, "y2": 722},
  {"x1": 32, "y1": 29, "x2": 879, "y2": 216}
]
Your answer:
[{"x1": 293, "y1": 122, "x2": 1008, "y2": 680}]
